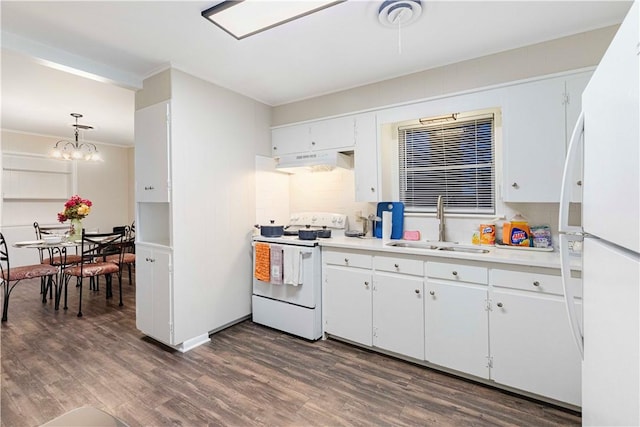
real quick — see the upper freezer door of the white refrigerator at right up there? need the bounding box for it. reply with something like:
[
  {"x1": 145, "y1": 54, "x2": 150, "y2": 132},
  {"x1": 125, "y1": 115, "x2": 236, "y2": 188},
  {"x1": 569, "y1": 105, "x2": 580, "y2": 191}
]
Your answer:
[{"x1": 582, "y1": 1, "x2": 640, "y2": 253}]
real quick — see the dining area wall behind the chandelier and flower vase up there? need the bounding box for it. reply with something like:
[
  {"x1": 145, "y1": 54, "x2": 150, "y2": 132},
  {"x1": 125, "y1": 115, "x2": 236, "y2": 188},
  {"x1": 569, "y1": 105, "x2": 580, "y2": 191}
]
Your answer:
[{"x1": 0, "y1": 130, "x2": 134, "y2": 265}]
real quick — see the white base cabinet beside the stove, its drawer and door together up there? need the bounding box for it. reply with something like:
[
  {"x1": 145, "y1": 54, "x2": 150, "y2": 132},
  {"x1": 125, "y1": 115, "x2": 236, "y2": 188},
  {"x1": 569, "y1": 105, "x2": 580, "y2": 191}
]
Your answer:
[{"x1": 322, "y1": 251, "x2": 373, "y2": 346}]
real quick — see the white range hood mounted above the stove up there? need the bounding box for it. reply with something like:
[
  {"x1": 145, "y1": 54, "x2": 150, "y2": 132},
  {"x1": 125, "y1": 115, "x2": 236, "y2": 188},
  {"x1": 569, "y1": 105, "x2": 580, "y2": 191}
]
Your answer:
[{"x1": 276, "y1": 150, "x2": 353, "y2": 173}]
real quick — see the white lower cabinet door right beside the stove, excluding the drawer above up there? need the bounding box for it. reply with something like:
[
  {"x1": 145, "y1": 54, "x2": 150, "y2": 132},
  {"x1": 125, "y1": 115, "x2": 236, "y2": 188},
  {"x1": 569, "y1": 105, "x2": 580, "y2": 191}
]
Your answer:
[{"x1": 323, "y1": 265, "x2": 372, "y2": 346}]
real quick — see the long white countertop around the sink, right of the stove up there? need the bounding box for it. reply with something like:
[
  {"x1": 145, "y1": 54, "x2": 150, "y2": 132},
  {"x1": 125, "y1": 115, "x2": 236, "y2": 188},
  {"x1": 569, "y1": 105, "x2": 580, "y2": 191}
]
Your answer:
[{"x1": 320, "y1": 237, "x2": 582, "y2": 270}]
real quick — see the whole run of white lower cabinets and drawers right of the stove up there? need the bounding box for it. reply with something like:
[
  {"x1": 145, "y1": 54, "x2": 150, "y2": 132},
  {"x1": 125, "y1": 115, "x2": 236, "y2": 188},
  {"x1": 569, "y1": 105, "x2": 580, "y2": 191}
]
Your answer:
[{"x1": 322, "y1": 248, "x2": 581, "y2": 407}]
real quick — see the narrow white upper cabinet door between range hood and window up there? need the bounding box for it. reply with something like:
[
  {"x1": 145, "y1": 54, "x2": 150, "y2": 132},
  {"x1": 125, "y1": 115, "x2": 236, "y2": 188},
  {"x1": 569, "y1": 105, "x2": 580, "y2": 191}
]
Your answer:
[{"x1": 353, "y1": 113, "x2": 381, "y2": 202}]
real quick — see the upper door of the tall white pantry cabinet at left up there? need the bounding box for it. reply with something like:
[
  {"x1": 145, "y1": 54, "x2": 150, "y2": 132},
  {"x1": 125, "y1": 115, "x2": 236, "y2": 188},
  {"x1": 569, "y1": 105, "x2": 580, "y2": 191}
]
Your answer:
[{"x1": 135, "y1": 102, "x2": 169, "y2": 202}]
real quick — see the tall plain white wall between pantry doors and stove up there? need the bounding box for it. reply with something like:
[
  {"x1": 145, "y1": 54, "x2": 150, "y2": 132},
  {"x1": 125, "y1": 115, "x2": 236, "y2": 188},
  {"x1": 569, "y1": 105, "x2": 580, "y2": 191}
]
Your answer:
[{"x1": 166, "y1": 69, "x2": 271, "y2": 337}]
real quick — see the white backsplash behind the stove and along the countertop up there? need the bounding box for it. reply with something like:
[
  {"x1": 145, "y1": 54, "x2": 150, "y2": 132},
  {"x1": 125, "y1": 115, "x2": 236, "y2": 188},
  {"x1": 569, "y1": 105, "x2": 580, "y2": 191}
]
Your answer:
[{"x1": 256, "y1": 157, "x2": 580, "y2": 247}]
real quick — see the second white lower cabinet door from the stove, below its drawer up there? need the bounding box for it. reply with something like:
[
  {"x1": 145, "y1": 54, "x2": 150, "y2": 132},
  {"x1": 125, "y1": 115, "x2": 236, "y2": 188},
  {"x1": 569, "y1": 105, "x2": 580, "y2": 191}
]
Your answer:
[{"x1": 373, "y1": 274, "x2": 424, "y2": 360}]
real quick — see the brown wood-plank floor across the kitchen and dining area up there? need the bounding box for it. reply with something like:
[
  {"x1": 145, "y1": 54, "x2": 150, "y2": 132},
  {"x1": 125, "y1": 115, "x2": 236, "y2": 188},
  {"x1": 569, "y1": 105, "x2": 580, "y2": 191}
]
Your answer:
[{"x1": 0, "y1": 274, "x2": 581, "y2": 427}]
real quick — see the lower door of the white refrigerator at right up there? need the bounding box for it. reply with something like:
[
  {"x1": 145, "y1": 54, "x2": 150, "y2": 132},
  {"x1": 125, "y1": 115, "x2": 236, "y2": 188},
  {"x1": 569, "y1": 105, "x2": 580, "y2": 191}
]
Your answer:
[{"x1": 582, "y1": 238, "x2": 640, "y2": 426}]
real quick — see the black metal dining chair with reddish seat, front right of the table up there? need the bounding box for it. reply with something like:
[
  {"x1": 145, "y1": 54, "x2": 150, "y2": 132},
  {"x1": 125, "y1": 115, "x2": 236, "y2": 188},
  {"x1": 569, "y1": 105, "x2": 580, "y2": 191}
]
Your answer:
[{"x1": 64, "y1": 230, "x2": 124, "y2": 317}]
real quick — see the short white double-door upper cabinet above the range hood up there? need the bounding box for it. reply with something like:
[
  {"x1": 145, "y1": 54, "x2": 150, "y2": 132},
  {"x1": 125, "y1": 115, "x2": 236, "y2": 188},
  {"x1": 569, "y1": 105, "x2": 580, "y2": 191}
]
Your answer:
[{"x1": 271, "y1": 116, "x2": 355, "y2": 157}]
